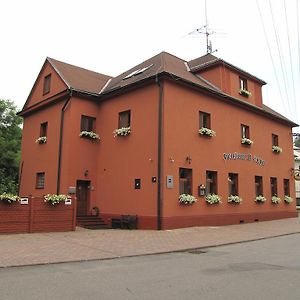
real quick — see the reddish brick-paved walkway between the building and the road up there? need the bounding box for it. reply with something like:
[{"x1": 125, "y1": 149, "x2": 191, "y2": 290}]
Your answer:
[{"x1": 0, "y1": 214, "x2": 300, "y2": 267}]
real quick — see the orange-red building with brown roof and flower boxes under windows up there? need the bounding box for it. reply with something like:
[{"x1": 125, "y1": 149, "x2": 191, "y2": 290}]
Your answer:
[{"x1": 20, "y1": 52, "x2": 297, "y2": 229}]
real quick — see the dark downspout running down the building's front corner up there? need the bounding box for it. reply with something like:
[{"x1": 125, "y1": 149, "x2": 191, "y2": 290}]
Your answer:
[{"x1": 155, "y1": 76, "x2": 164, "y2": 230}]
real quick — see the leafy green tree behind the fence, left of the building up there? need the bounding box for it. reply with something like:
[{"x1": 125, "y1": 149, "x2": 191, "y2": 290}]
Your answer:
[{"x1": 0, "y1": 99, "x2": 22, "y2": 194}]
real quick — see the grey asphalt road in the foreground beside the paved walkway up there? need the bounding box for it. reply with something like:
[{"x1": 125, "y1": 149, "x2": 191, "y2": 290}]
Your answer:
[{"x1": 0, "y1": 234, "x2": 300, "y2": 300}]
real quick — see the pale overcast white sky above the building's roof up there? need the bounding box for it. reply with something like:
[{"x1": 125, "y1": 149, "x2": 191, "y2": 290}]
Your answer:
[{"x1": 0, "y1": 0, "x2": 300, "y2": 132}]
